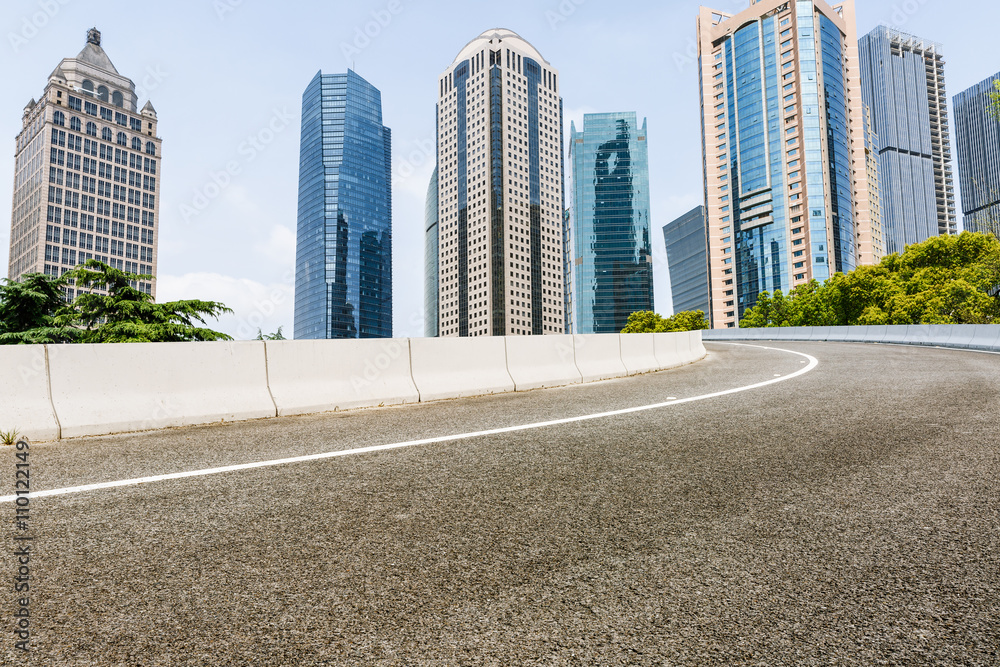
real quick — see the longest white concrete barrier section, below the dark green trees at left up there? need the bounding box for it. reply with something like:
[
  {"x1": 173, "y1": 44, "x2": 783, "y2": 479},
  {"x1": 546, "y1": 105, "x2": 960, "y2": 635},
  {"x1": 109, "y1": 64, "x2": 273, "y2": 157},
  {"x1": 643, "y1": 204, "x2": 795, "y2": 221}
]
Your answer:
[{"x1": 49, "y1": 342, "x2": 277, "y2": 438}]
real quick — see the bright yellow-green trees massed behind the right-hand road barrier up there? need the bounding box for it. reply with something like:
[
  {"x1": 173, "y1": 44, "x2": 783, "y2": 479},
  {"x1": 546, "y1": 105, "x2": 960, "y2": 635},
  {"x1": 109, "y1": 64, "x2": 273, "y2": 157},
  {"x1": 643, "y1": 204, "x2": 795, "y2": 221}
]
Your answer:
[{"x1": 740, "y1": 232, "x2": 1000, "y2": 327}]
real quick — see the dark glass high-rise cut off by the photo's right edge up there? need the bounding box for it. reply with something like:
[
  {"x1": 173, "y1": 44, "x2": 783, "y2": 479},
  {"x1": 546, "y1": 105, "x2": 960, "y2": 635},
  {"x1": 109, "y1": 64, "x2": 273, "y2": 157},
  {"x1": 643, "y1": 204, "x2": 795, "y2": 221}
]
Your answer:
[{"x1": 954, "y1": 72, "x2": 1000, "y2": 237}]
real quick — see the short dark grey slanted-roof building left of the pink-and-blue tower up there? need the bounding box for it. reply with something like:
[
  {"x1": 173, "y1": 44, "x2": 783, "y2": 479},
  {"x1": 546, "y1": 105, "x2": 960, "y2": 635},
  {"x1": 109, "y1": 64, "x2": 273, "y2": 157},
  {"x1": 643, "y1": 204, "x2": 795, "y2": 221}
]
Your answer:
[{"x1": 663, "y1": 206, "x2": 711, "y2": 314}]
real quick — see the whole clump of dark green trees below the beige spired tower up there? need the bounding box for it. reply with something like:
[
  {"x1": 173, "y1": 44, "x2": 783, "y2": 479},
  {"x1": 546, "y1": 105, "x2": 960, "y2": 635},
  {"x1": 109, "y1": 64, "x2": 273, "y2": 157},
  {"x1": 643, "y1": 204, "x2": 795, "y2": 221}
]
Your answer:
[{"x1": 0, "y1": 259, "x2": 232, "y2": 344}]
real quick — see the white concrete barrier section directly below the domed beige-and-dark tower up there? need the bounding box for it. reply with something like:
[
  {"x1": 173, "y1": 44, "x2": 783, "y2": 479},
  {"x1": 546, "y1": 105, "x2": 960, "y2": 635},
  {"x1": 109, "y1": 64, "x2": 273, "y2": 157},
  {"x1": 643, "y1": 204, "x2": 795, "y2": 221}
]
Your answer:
[{"x1": 410, "y1": 336, "x2": 514, "y2": 401}]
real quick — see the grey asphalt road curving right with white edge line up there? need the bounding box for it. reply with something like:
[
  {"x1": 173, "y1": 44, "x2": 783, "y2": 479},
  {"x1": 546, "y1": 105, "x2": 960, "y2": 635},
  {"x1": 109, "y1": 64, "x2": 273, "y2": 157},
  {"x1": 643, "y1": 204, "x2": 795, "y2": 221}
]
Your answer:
[{"x1": 0, "y1": 342, "x2": 1000, "y2": 665}]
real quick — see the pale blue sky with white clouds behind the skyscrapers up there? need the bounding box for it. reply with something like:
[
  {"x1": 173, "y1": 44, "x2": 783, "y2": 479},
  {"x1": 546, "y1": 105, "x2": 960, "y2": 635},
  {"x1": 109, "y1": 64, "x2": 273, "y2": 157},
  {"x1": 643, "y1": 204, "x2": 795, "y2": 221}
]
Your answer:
[{"x1": 0, "y1": 0, "x2": 1000, "y2": 339}]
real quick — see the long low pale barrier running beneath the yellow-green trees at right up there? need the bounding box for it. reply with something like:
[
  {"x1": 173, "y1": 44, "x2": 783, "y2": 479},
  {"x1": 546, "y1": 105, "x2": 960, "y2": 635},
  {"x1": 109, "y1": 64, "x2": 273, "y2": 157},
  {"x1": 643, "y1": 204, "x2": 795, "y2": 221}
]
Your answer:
[{"x1": 702, "y1": 324, "x2": 1000, "y2": 352}]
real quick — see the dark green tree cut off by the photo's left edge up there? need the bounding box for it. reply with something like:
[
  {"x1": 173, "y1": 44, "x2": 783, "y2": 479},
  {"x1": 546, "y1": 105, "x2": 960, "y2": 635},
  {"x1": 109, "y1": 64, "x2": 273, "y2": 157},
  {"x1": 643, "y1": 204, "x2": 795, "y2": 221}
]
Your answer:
[{"x1": 0, "y1": 273, "x2": 80, "y2": 345}]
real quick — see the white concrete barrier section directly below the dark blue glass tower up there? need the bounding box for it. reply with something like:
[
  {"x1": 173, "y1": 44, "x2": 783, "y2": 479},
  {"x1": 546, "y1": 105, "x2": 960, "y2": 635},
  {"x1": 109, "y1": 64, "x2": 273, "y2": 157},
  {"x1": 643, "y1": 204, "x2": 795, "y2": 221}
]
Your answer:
[{"x1": 266, "y1": 338, "x2": 420, "y2": 416}]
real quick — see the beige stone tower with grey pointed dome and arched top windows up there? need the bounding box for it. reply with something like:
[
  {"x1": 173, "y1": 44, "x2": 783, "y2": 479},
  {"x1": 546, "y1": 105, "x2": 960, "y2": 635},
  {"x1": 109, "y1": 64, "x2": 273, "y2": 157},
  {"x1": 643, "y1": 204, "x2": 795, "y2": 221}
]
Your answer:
[{"x1": 8, "y1": 28, "x2": 162, "y2": 298}]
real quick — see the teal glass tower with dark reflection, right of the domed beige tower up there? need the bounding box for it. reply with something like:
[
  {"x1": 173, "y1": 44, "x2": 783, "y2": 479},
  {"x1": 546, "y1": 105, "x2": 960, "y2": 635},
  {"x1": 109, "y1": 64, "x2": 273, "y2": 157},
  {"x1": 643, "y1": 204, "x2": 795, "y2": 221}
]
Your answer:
[{"x1": 569, "y1": 112, "x2": 653, "y2": 334}]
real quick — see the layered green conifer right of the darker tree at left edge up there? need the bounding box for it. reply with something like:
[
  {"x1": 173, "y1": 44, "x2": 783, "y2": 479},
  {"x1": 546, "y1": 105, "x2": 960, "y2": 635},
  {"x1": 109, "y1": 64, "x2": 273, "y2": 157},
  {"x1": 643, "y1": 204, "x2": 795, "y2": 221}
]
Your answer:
[{"x1": 66, "y1": 259, "x2": 233, "y2": 343}]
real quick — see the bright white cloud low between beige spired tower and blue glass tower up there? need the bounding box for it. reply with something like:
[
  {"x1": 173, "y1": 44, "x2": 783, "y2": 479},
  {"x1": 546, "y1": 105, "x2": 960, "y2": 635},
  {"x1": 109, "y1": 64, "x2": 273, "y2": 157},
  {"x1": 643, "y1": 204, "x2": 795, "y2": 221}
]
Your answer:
[{"x1": 156, "y1": 273, "x2": 295, "y2": 340}]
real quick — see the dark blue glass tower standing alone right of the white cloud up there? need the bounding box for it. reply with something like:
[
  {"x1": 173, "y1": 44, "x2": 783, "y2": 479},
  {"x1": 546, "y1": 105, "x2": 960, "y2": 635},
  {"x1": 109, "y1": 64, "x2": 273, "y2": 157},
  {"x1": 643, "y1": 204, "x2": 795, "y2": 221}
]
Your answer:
[{"x1": 295, "y1": 71, "x2": 392, "y2": 339}]
